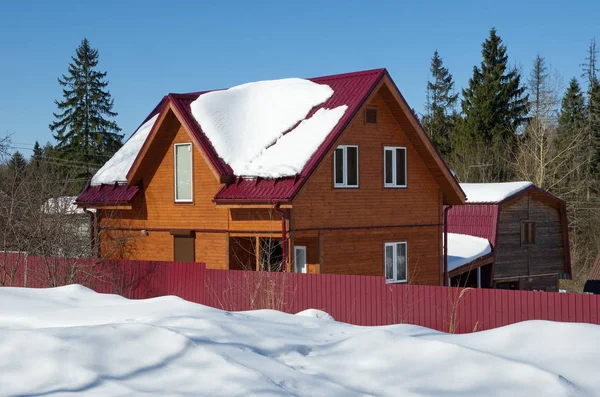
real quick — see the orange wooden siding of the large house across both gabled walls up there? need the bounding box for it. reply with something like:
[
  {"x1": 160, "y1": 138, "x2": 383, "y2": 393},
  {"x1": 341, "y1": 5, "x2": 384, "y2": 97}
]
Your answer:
[{"x1": 99, "y1": 90, "x2": 443, "y2": 284}]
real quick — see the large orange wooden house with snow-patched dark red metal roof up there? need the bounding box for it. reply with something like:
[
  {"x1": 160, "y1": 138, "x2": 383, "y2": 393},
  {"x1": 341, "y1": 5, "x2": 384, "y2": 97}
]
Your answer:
[{"x1": 77, "y1": 69, "x2": 464, "y2": 285}]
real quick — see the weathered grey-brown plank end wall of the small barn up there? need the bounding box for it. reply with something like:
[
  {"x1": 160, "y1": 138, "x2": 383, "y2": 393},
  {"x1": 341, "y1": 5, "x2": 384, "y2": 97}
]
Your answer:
[{"x1": 494, "y1": 192, "x2": 567, "y2": 285}]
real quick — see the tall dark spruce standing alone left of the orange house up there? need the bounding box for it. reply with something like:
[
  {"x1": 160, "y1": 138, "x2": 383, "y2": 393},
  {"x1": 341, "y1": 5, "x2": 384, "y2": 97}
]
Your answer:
[{"x1": 50, "y1": 39, "x2": 123, "y2": 178}]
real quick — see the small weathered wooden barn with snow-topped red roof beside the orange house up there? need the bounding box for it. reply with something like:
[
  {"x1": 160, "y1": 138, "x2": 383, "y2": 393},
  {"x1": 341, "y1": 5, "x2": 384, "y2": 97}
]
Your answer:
[{"x1": 448, "y1": 182, "x2": 571, "y2": 291}]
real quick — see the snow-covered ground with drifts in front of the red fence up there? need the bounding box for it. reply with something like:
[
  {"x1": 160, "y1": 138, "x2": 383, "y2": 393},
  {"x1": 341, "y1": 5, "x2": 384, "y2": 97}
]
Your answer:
[{"x1": 0, "y1": 285, "x2": 600, "y2": 397}]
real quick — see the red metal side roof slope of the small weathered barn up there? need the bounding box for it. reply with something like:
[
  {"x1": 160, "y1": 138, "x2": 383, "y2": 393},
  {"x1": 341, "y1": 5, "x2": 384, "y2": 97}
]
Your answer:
[{"x1": 448, "y1": 204, "x2": 499, "y2": 247}]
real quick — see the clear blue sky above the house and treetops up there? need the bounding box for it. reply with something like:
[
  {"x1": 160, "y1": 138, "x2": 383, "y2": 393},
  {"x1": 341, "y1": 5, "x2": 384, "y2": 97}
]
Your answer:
[{"x1": 0, "y1": 0, "x2": 600, "y2": 155}]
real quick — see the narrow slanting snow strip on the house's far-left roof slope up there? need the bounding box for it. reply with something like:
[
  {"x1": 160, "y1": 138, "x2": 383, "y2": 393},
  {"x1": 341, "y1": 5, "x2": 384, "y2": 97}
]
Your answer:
[{"x1": 91, "y1": 114, "x2": 158, "y2": 186}]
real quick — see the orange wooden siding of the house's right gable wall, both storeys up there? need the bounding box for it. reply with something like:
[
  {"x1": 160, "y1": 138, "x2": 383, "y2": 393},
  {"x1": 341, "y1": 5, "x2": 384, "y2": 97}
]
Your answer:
[{"x1": 291, "y1": 89, "x2": 442, "y2": 284}]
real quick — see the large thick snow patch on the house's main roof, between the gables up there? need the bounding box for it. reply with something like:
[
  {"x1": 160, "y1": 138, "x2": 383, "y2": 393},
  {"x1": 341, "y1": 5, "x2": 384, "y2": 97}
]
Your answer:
[{"x1": 191, "y1": 78, "x2": 347, "y2": 178}]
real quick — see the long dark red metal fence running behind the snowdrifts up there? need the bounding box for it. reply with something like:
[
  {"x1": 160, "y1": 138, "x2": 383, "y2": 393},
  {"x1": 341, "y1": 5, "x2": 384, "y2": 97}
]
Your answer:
[{"x1": 0, "y1": 254, "x2": 600, "y2": 333}]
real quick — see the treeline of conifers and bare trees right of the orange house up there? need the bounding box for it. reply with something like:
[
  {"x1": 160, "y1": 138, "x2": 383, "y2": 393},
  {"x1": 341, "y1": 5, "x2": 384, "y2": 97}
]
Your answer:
[{"x1": 420, "y1": 29, "x2": 600, "y2": 290}]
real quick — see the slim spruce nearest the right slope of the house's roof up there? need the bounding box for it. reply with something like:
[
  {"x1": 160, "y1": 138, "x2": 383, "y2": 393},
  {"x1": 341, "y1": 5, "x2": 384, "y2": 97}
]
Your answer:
[{"x1": 422, "y1": 50, "x2": 458, "y2": 155}]
